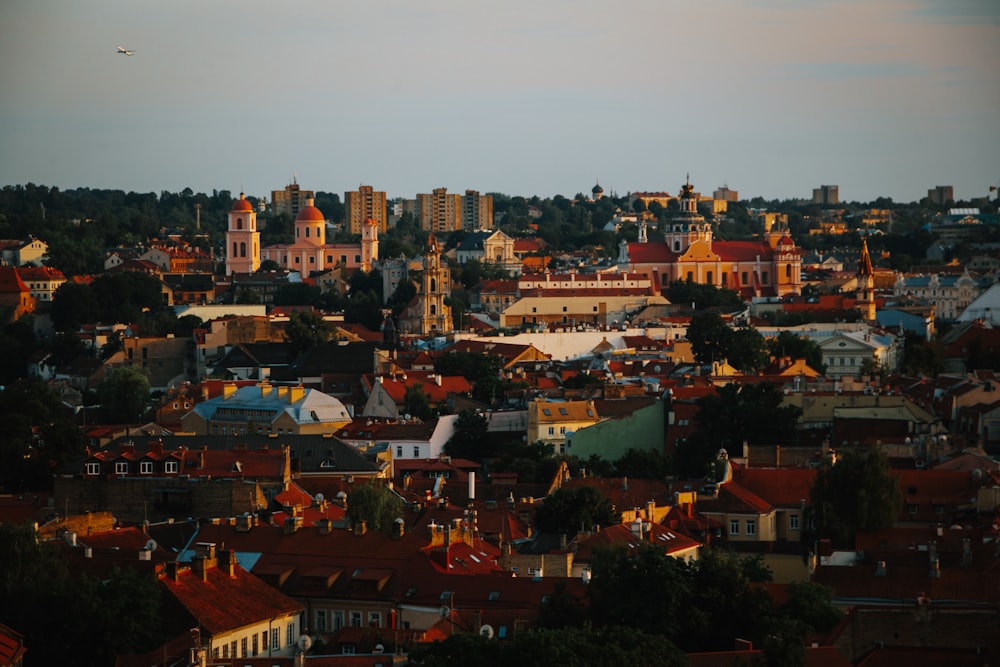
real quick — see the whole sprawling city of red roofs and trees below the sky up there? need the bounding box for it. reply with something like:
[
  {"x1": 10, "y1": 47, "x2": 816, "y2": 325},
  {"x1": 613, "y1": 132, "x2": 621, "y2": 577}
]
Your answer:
[{"x1": 0, "y1": 176, "x2": 1000, "y2": 667}]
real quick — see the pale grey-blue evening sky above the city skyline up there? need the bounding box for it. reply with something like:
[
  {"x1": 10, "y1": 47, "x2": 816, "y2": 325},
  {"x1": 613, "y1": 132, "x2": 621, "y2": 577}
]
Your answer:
[{"x1": 0, "y1": 0, "x2": 1000, "y2": 202}]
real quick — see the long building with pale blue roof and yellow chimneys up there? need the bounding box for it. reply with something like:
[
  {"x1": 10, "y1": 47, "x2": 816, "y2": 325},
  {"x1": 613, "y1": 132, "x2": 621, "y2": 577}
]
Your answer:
[{"x1": 181, "y1": 382, "x2": 351, "y2": 435}]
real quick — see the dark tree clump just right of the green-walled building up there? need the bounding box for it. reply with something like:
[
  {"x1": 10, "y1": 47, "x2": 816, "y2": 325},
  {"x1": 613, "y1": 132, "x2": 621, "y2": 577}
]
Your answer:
[{"x1": 674, "y1": 382, "x2": 802, "y2": 477}]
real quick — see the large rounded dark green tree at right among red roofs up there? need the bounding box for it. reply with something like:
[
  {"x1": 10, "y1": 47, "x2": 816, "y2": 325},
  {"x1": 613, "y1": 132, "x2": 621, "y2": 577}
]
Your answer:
[{"x1": 804, "y1": 447, "x2": 903, "y2": 547}]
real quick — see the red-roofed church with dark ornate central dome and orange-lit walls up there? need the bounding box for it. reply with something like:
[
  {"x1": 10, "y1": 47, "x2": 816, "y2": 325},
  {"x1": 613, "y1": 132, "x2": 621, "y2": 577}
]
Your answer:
[{"x1": 618, "y1": 181, "x2": 802, "y2": 300}]
